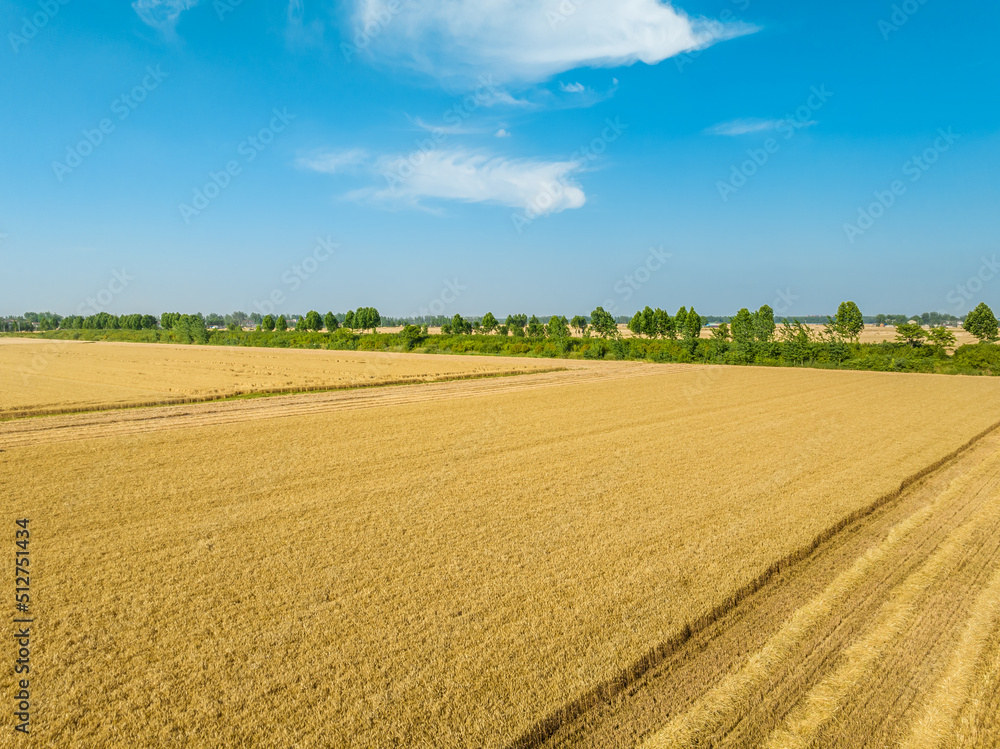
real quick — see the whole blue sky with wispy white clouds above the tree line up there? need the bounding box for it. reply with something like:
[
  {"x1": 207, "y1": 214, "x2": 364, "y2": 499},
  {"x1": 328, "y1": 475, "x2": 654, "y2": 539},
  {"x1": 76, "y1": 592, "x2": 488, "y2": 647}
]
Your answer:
[{"x1": 0, "y1": 0, "x2": 1000, "y2": 316}]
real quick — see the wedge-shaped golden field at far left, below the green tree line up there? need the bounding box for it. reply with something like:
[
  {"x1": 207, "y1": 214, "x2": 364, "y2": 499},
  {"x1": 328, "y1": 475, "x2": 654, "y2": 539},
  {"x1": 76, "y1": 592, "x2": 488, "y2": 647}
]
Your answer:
[{"x1": 0, "y1": 338, "x2": 558, "y2": 419}]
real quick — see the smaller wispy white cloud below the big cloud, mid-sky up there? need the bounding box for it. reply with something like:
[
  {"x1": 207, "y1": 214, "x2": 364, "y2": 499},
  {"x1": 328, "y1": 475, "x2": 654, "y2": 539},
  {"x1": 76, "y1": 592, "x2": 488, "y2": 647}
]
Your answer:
[{"x1": 340, "y1": 150, "x2": 587, "y2": 216}]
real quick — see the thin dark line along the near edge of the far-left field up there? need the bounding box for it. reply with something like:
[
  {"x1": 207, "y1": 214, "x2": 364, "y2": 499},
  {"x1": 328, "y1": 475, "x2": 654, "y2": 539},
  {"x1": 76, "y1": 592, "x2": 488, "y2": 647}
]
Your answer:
[{"x1": 0, "y1": 367, "x2": 566, "y2": 422}]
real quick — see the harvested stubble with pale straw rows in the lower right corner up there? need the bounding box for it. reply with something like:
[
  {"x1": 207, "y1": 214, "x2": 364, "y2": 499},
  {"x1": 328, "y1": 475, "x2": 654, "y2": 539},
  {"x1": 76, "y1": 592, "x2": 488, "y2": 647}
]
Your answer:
[{"x1": 532, "y1": 432, "x2": 1000, "y2": 749}]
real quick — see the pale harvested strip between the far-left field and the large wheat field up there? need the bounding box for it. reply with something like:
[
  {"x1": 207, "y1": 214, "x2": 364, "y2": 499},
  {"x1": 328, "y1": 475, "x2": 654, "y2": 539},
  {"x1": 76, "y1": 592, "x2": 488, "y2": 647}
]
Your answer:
[{"x1": 0, "y1": 362, "x2": 680, "y2": 449}]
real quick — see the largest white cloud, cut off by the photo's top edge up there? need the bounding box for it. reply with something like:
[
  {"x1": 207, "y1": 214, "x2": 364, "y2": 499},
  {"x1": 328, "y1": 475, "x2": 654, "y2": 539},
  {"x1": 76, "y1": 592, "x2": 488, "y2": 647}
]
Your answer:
[{"x1": 354, "y1": 0, "x2": 756, "y2": 86}]
